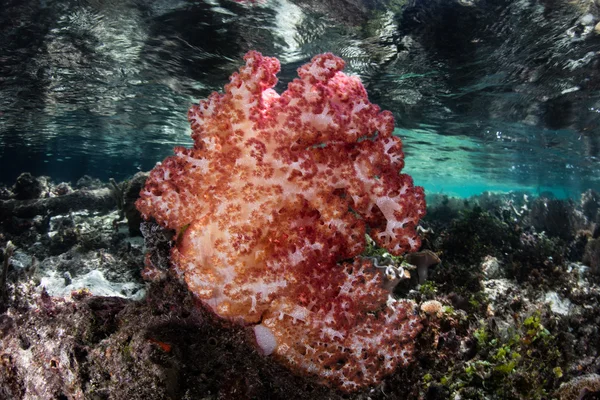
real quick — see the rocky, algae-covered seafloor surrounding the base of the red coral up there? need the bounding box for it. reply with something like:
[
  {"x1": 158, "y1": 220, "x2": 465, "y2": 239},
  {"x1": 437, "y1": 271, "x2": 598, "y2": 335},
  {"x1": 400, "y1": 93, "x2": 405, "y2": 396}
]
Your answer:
[{"x1": 0, "y1": 174, "x2": 600, "y2": 400}]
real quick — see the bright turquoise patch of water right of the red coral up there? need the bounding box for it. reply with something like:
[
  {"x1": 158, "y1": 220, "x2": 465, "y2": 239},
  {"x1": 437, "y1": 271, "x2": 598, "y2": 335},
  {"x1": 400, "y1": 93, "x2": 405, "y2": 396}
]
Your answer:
[{"x1": 396, "y1": 129, "x2": 599, "y2": 198}]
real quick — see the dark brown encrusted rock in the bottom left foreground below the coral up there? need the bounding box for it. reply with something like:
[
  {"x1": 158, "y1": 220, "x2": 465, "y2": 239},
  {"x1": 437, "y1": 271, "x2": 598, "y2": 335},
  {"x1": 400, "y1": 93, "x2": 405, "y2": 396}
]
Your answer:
[{"x1": 0, "y1": 280, "x2": 341, "y2": 400}]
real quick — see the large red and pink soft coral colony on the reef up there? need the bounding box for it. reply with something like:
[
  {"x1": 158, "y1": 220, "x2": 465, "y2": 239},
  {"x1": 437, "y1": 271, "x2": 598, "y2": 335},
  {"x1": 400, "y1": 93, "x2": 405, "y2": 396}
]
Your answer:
[{"x1": 137, "y1": 51, "x2": 425, "y2": 390}]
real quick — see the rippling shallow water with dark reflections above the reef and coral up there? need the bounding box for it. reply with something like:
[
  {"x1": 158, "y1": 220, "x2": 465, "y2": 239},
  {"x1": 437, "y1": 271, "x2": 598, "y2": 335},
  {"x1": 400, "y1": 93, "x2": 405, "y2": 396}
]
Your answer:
[{"x1": 0, "y1": 0, "x2": 600, "y2": 197}]
